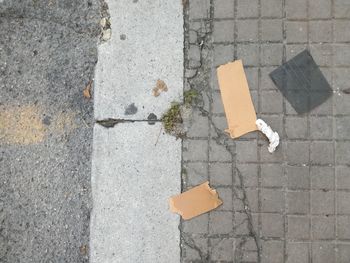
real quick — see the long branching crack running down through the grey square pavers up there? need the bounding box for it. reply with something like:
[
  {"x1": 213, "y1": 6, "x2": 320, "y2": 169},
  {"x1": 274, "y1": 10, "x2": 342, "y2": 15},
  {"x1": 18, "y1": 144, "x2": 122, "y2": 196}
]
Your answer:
[{"x1": 181, "y1": 11, "x2": 261, "y2": 262}]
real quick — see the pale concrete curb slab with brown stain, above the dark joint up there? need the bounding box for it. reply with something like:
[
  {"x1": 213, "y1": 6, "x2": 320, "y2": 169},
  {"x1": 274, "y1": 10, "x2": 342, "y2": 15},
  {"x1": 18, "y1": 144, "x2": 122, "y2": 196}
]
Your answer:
[{"x1": 95, "y1": 0, "x2": 183, "y2": 120}]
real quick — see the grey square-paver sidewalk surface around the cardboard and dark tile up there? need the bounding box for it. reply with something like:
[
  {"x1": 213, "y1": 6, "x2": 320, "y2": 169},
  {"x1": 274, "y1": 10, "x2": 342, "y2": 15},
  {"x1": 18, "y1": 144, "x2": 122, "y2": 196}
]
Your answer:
[{"x1": 181, "y1": 0, "x2": 350, "y2": 263}]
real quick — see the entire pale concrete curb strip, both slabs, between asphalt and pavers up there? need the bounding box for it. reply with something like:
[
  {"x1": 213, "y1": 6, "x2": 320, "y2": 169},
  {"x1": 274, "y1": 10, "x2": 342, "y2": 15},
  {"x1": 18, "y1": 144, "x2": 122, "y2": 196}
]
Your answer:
[{"x1": 90, "y1": 0, "x2": 183, "y2": 263}]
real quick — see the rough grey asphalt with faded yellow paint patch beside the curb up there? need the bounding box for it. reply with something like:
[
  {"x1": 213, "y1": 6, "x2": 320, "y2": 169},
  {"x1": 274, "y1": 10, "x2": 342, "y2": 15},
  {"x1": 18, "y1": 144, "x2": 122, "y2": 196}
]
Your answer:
[{"x1": 0, "y1": 0, "x2": 100, "y2": 263}]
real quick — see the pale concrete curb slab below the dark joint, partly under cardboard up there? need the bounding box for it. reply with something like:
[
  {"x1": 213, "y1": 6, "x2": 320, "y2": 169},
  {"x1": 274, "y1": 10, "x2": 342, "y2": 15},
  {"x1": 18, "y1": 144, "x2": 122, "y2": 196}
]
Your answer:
[{"x1": 90, "y1": 122, "x2": 181, "y2": 263}]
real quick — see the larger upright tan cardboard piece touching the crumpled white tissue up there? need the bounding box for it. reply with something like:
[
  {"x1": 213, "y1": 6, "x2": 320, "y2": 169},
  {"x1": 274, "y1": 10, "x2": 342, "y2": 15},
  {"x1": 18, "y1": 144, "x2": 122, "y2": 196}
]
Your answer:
[{"x1": 217, "y1": 60, "x2": 257, "y2": 138}]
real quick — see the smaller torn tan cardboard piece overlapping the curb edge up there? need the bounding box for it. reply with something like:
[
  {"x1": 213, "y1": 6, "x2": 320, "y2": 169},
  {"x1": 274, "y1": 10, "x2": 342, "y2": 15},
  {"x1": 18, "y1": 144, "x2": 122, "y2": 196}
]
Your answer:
[{"x1": 169, "y1": 181, "x2": 222, "y2": 220}]
